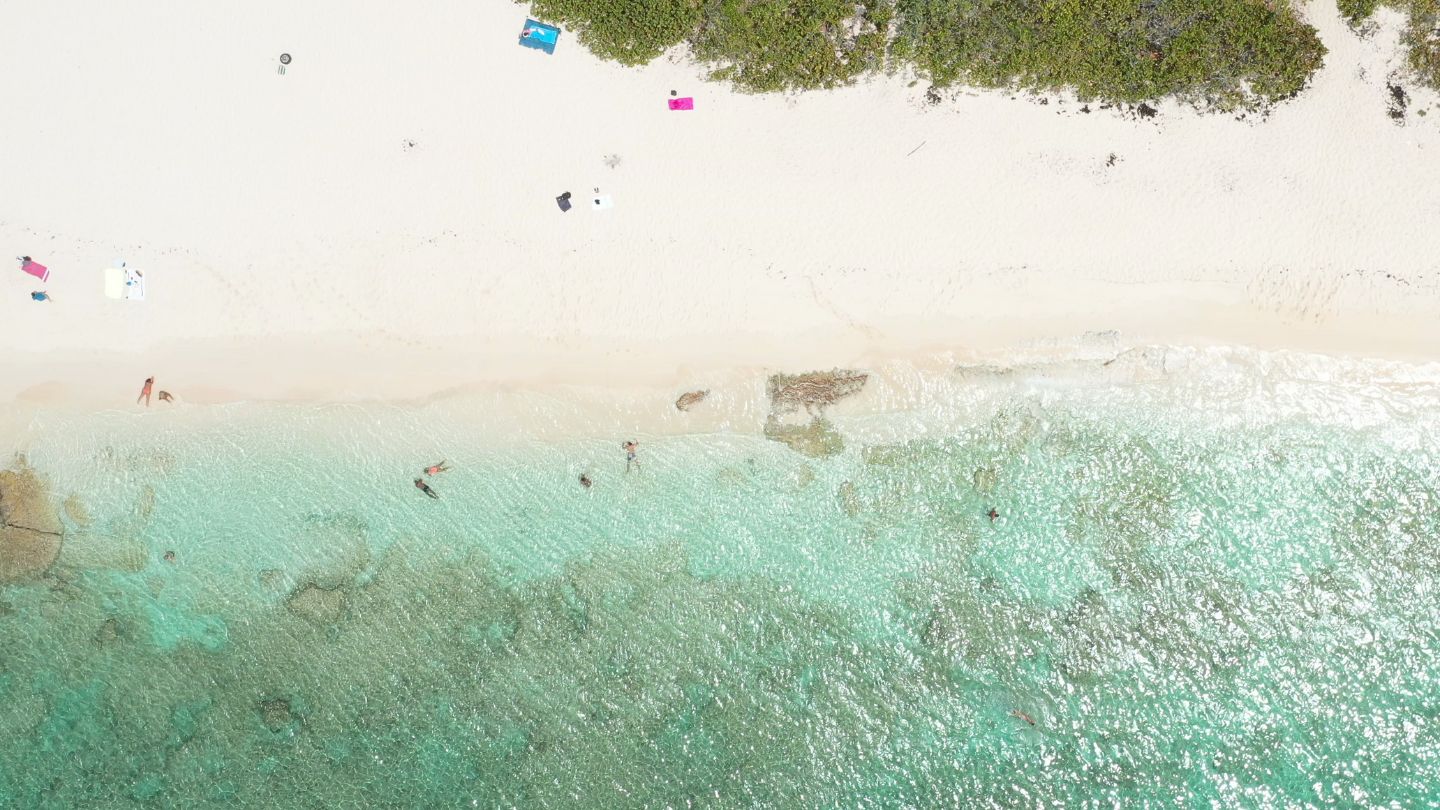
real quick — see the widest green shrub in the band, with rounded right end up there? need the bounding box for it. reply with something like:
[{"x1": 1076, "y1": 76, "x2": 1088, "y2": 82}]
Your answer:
[{"x1": 899, "y1": 0, "x2": 1325, "y2": 110}]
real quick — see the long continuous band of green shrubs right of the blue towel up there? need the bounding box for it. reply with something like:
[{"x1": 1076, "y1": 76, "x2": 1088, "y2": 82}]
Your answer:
[{"x1": 518, "y1": 0, "x2": 1324, "y2": 110}]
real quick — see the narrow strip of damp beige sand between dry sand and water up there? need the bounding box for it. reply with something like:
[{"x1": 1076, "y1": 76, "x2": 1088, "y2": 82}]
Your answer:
[{"x1": 0, "y1": 292, "x2": 1440, "y2": 408}]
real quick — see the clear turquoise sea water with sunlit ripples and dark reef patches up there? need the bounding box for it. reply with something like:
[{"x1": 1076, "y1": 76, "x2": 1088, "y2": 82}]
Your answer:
[{"x1": 0, "y1": 349, "x2": 1440, "y2": 807}]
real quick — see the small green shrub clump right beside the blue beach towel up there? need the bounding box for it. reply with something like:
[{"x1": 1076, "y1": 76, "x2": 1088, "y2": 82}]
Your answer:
[{"x1": 531, "y1": 0, "x2": 700, "y2": 65}]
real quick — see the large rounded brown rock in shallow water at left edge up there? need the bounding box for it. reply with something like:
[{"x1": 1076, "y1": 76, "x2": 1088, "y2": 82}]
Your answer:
[{"x1": 0, "y1": 458, "x2": 63, "y2": 582}]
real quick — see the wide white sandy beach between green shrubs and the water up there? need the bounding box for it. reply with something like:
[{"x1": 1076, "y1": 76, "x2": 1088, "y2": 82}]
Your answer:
[{"x1": 0, "y1": 0, "x2": 1440, "y2": 404}]
